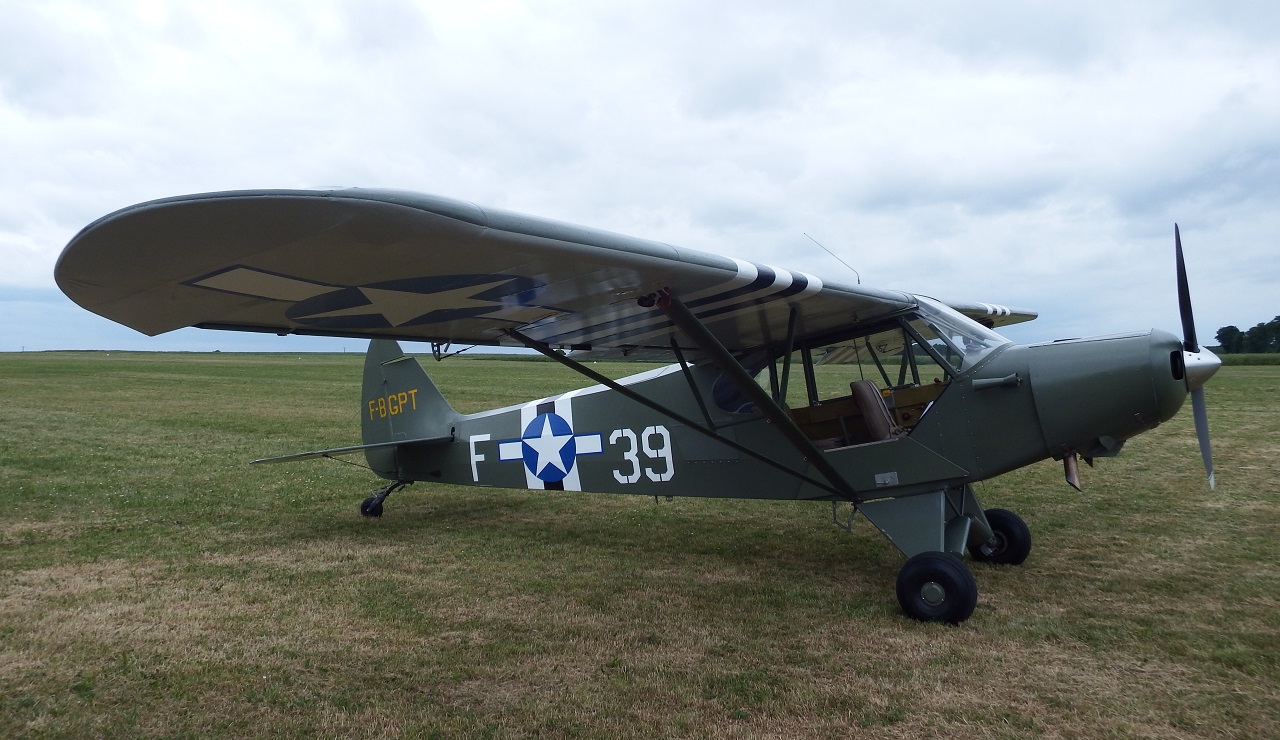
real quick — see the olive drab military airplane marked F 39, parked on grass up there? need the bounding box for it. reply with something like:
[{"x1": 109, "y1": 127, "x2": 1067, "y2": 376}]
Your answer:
[{"x1": 56, "y1": 189, "x2": 1219, "y2": 622}]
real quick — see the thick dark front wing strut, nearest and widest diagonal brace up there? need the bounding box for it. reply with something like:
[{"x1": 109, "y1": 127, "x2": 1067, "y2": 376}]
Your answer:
[{"x1": 658, "y1": 293, "x2": 858, "y2": 501}]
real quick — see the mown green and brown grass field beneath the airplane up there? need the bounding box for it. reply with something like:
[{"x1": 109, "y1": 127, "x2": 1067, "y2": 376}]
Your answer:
[{"x1": 0, "y1": 353, "x2": 1280, "y2": 737}]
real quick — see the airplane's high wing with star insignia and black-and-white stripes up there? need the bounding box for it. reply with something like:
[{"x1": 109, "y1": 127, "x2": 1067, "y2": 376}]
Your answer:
[{"x1": 55, "y1": 188, "x2": 1036, "y2": 357}]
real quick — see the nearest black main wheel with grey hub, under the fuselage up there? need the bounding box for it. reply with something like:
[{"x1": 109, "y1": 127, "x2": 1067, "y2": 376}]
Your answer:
[{"x1": 897, "y1": 552, "x2": 978, "y2": 625}]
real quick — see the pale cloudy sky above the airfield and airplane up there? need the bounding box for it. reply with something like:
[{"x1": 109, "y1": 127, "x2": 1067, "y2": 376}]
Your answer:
[{"x1": 0, "y1": 0, "x2": 1280, "y2": 351}]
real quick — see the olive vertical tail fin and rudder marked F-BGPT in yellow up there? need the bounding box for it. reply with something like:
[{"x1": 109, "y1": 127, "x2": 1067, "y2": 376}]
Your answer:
[{"x1": 361, "y1": 339, "x2": 460, "y2": 445}]
